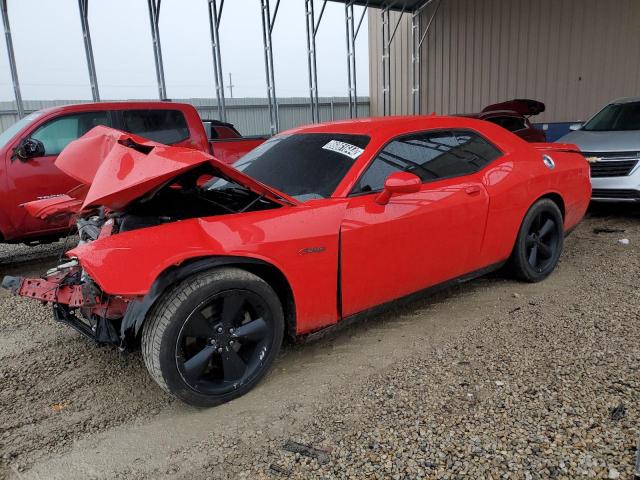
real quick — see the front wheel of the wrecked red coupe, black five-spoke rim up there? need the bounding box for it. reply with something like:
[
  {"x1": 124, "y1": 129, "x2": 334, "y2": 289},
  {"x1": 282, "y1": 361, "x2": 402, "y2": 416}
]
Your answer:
[{"x1": 142, "y1": 267, "x2": 284, "y2": 407}]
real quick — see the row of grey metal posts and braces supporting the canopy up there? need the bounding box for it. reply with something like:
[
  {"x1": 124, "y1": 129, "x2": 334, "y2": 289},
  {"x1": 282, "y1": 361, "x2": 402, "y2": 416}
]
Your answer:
[{"x1": 0, "y1": 0, "x2": 442, "y2": 127}]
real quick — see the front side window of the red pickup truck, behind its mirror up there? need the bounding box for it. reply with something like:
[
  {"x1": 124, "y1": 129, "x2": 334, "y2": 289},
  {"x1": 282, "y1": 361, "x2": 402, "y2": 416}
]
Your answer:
[{"x1": 31, "y1": 111, "x2": 111, "y2": 155}]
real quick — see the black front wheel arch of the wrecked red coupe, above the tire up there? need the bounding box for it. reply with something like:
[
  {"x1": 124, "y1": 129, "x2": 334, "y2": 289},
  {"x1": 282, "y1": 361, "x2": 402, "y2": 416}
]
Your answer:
[{"x1": 120, "y1": 256, "x2": 296, "y2": 340}]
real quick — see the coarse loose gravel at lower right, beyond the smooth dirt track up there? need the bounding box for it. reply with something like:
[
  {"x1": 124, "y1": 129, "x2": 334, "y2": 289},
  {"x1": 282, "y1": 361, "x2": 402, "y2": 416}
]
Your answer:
[{"x1": 246, "y1": 231, "x2": 640, "y2": 479}]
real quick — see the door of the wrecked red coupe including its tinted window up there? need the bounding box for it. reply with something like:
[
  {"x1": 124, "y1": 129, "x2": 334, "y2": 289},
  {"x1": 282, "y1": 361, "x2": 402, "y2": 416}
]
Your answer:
[{"x1": 340, "y1": 131, "x2": 501, "y2": 316}]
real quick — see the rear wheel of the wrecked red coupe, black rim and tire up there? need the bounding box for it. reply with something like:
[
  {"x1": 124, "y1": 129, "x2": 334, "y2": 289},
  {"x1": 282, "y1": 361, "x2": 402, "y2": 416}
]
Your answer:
[{"x1": 510, "y1": 198, "x2": 564, "y2": 283}]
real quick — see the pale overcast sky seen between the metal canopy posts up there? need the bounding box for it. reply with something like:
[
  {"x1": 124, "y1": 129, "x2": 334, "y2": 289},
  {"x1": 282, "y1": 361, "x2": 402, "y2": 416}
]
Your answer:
[{"x1": 0, "y1": 0, "x2": 369, "y2": 100}]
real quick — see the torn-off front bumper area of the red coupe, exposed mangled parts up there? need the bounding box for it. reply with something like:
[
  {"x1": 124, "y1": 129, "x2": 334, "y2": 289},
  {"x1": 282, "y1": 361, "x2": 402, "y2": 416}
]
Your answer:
[{"x1": 2, "y1": 266, "x2": 128, "y2": 346}]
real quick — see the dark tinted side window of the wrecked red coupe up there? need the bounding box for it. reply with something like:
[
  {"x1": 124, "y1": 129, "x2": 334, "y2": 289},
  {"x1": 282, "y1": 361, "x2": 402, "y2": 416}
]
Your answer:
[{"x1": 352, "y1": 130, "x2": 501, "y2": 193}]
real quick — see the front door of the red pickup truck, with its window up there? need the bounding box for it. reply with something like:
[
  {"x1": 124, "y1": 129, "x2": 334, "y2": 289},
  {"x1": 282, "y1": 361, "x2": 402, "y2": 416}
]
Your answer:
[{"x1": 7, "y1": 110, "x2": 111, "y2": 235}]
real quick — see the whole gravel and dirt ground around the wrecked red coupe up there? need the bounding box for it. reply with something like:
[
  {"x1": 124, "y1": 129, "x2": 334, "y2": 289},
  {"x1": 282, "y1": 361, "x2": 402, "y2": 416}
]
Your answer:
[{"x1": 0, "y1": 207, "x2": 640, "y2": 480}]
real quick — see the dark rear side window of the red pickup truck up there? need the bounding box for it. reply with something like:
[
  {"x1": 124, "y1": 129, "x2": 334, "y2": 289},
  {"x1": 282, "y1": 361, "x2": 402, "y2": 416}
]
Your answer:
[{"x1": 122, "y1": 110, "x2": 189, "y2": 145}]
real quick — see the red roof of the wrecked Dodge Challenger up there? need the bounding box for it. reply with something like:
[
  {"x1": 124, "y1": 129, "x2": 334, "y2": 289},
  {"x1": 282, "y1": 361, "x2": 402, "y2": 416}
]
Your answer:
[{"x1": 281, "y1": 115, "x2": 498, "y2": 137}]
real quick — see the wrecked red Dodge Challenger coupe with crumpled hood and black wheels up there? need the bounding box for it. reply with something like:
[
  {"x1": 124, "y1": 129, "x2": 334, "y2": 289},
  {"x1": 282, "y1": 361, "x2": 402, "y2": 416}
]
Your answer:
[{"x1": 3, "y1": 116, "x2": 591, "y2": 406}]
